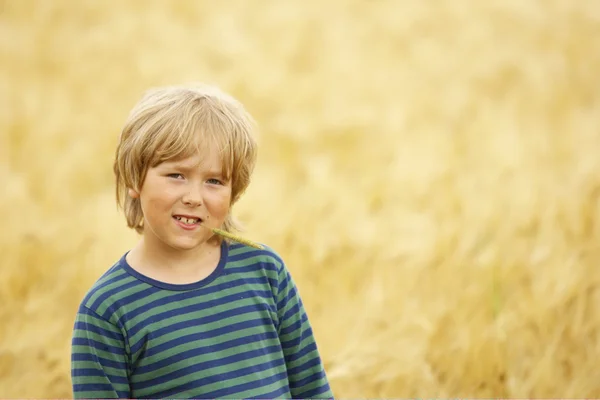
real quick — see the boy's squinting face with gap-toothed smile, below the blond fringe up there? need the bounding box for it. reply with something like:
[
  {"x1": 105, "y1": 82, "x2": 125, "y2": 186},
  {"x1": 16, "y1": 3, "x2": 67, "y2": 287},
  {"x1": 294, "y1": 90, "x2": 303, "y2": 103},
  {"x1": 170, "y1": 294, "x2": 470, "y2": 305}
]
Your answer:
[{"x1": 129, "y1": 146, "x2": 231, "y2": 251}]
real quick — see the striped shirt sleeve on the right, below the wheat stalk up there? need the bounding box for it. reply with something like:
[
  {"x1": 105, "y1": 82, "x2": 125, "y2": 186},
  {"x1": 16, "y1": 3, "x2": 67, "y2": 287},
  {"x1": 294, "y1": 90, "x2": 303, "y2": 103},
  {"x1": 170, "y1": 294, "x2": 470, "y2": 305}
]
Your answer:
[{"x1": 277, "y1": 265, "x2": 333, "y2": 399}]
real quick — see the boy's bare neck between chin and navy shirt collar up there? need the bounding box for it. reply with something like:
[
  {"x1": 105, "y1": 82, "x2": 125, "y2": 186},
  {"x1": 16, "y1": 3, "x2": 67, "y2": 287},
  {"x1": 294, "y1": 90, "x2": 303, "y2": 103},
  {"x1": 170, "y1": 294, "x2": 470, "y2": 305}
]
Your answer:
[{"x1": 127, "y1": 237, "x2": 221, "y2": 284}]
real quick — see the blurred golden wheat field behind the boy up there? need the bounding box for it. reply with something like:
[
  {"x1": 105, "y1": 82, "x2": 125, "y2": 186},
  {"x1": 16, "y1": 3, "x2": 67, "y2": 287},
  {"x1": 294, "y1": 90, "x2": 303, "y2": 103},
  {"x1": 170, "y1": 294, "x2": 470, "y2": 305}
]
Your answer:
[{"x1": 0, "y1": 0, "x2": 600, "y2": 398}]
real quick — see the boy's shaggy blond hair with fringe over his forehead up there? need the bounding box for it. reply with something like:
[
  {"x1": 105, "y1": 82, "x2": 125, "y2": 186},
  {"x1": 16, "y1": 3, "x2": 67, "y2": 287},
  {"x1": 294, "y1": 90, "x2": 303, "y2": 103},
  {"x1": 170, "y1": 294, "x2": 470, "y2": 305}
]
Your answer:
[{"x1": 113, "y1": 84, "x2": 257, "y2": 233}]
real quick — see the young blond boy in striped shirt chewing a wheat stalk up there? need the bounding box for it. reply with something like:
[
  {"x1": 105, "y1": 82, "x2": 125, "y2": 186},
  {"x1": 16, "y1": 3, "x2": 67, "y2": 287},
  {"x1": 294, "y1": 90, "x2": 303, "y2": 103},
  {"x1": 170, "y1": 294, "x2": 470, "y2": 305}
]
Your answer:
[{"x1": 71, "y1": 85, "x2": 333, "y2": 399}]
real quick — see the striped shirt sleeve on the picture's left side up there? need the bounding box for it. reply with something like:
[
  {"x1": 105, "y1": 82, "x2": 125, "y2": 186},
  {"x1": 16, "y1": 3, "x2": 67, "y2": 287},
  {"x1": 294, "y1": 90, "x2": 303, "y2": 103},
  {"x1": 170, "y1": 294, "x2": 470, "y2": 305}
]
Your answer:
[{"x1": 71, "y1": 305, "x2": 131, "y2": 399}]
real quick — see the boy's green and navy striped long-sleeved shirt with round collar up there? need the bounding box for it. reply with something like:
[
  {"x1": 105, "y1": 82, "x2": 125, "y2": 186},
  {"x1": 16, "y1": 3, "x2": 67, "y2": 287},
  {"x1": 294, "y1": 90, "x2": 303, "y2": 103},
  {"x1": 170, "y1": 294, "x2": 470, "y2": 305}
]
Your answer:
[{"x1": 71, "y1": 241, "x2": 333, "y2": 398}]
